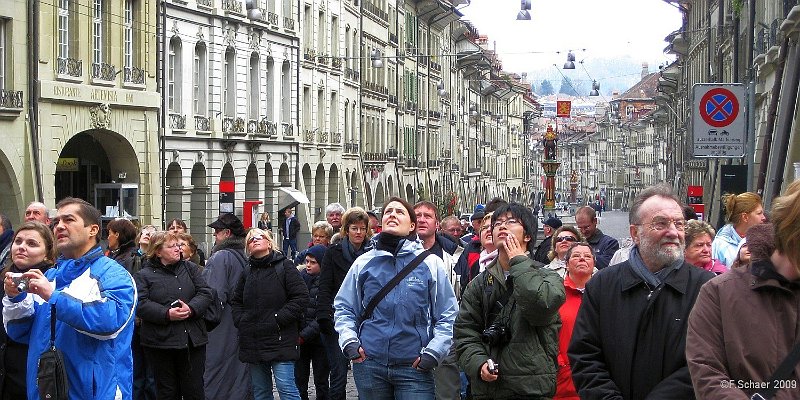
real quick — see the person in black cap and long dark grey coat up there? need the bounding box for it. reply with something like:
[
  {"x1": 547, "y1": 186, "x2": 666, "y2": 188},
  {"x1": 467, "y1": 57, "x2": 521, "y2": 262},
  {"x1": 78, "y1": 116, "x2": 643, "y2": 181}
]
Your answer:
[{"x1": 203, "y1": 214, "x2": 250, "y2": 400}]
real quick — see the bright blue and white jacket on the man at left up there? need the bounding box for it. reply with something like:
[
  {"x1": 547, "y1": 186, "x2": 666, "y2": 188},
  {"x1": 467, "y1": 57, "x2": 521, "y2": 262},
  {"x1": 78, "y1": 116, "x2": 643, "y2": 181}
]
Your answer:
[{"x1": 3, "y1": 246, "x2": 136, "y2": 400}]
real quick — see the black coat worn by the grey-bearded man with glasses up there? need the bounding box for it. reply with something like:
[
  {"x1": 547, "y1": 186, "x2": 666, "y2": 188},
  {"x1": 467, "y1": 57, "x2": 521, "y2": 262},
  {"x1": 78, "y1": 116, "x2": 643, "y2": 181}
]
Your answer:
[{"x1": 567, "y1": 261, "x2": 714, "y2": 400}]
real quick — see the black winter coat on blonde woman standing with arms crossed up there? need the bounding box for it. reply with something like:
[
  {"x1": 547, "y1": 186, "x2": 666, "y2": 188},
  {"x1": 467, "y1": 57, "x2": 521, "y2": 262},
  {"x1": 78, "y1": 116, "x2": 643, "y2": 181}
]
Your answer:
[{"x1": 230, "y1": 251, "x2": 308, "y2": 364}]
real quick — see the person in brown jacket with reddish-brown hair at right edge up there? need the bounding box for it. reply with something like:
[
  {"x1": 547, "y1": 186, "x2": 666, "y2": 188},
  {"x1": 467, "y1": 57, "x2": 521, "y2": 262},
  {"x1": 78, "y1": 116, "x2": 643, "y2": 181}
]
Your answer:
[{"x1": 686, "y1": 181, "x2": 800, "y2": 399}]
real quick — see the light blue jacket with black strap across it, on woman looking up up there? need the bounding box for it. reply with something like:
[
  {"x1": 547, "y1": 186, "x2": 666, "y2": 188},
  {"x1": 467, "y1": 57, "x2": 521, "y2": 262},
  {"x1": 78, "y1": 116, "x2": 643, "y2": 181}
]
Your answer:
[{"x1": 333, "y1": 240, "x2": 458, "y2": 365}]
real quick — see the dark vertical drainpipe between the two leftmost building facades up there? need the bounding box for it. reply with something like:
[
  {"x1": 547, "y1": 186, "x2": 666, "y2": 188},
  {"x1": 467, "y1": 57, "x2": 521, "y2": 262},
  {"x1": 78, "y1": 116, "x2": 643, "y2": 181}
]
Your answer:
[{"x1": 28, "y1": 0, "x2": 44, "y2": 203}]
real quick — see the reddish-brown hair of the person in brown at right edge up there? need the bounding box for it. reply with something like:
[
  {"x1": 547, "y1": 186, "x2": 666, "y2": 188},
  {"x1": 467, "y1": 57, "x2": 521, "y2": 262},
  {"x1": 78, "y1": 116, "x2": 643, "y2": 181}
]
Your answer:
[{"x1": 770, "y1": 180, "x2": 800, "y2": 272}]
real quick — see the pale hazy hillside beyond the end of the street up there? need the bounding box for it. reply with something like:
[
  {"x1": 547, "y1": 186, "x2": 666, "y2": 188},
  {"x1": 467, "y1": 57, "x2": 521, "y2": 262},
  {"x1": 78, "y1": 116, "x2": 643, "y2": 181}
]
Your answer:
[{"x1": 528, "y1": 56, "x2": 664, "y2": 100}]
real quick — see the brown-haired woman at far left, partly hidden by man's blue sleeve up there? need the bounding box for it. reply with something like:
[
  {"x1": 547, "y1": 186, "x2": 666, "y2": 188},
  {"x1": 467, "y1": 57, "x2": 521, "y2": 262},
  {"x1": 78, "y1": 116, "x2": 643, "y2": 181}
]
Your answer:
[{"x1": 0, "y1": 222, "x2": 56, "y2": 399}]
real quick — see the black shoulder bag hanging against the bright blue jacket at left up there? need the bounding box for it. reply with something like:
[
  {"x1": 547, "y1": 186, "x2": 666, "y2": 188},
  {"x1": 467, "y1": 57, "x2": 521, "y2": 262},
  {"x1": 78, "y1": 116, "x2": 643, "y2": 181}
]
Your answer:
[{"x1": 36, "y1": 305, "x2": 69, "y2": 400}]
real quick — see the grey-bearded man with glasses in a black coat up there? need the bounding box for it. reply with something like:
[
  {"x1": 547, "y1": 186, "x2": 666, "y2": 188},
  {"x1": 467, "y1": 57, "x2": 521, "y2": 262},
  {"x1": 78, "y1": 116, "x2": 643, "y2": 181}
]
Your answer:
[{"x1": 568, "y1": 185, "x2": 714, "y2": 399}]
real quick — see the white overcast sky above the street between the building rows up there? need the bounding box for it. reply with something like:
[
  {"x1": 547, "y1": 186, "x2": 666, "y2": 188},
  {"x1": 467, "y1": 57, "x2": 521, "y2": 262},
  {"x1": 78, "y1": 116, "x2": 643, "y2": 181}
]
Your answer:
[{"x1": 460, "y1": 0, "x2": 681, "y2": 72}]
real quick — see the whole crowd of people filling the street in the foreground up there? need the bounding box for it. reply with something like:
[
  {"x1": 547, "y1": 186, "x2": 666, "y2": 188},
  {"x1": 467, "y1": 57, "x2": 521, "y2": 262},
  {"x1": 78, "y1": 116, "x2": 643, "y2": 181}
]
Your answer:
[{"x1": 0, "y1": 182, "x2": 800, "y2": 400}]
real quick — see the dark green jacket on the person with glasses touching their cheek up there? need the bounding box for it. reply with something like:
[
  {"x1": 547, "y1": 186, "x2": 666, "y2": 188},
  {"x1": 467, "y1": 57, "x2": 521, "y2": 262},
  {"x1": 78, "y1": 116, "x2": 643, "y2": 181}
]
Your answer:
[{"x1": 454, "y1": 256, "x2": 565, "y2": 399}]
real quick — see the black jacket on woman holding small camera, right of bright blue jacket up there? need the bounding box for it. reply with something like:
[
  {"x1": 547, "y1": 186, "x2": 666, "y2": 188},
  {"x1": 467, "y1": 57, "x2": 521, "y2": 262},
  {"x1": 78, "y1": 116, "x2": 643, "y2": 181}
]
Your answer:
[{"x1": 134, "y1": 258, "x2": 211, "y2": 349}]
